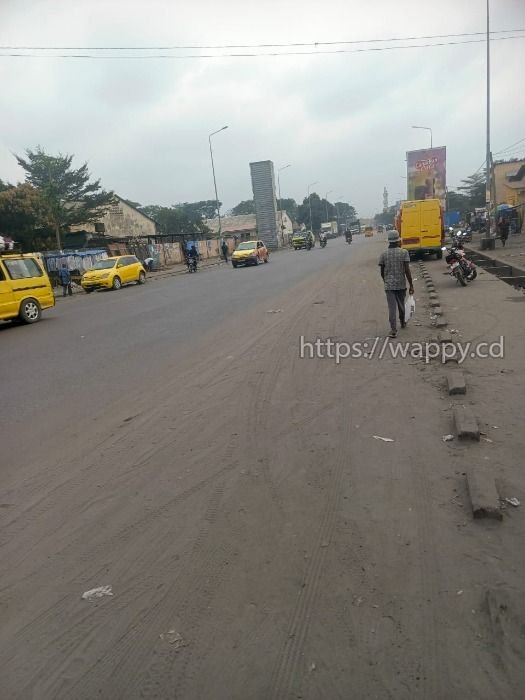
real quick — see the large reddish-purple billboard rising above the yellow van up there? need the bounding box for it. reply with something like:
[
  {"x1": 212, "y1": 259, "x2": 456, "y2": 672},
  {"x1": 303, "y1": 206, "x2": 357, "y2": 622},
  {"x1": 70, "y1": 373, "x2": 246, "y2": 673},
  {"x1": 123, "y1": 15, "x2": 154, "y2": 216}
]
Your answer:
[{"x1": 407, "y1": 146, "x2": 447, "y2": 208}]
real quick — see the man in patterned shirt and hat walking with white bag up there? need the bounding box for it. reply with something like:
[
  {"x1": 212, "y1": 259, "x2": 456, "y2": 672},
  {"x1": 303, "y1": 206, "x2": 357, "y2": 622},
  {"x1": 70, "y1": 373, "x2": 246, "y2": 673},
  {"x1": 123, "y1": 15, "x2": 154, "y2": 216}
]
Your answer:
[{"x1": 379, "y1": 230, "x2": 414, "y2": 338}]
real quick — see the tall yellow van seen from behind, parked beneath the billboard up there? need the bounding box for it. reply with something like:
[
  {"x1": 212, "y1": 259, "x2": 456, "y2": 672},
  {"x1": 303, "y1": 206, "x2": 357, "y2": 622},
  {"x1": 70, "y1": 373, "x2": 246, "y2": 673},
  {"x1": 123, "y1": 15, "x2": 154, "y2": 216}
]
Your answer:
[{"x1": 396, "y1": 199, "x2": 445, "y2": 260}]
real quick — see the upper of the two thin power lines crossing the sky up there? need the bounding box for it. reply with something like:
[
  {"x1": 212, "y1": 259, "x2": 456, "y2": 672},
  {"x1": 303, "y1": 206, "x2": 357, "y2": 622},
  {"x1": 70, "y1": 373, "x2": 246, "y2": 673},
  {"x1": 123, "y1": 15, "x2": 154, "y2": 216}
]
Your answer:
[{"x1": 0, "y1": 27, "x2": 525, "y2": 51}]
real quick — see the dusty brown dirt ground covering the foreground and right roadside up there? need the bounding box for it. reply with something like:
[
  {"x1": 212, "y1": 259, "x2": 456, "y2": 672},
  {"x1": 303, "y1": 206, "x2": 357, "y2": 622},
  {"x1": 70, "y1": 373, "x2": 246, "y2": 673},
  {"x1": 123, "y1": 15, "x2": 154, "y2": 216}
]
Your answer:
[{"x1": 0, "y1": 239, "x2": 525, "y2": 700}]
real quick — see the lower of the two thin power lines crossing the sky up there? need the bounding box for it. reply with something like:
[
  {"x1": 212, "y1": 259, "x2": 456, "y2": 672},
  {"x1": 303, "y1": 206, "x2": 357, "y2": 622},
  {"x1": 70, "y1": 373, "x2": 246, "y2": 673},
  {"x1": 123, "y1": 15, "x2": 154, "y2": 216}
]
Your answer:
[{"x1": 0, "y1": 34, "x2": 525, "y2": 60}]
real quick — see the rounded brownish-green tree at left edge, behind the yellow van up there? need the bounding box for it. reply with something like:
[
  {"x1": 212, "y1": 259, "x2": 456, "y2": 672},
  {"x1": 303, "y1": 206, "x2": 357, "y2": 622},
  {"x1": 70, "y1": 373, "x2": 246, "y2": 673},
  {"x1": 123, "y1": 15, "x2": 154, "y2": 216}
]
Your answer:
[{"x1": 0, "y1": 183, "x2": 53, "y2": 252}]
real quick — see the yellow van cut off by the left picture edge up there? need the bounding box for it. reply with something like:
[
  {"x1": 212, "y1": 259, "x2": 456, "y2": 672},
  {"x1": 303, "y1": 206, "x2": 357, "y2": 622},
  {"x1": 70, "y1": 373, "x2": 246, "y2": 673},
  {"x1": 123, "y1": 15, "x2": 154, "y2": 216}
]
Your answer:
[{"x1": 0, "y1": 253, "x2": 55, "y2": 323}]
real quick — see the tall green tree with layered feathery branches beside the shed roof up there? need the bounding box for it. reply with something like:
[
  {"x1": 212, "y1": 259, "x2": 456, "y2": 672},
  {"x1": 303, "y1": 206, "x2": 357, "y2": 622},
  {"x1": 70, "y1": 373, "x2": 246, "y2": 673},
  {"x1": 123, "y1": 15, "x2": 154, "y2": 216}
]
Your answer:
[{"x1": 16, "y1": 146, "x2": 114, "y2": 250}]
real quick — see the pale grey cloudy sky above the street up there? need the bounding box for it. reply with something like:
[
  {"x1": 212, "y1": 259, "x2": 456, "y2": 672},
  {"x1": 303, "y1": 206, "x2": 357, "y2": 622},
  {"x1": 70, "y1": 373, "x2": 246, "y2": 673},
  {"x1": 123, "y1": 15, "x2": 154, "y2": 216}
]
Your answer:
[{"x1": 0, "y1": 0, "x2": 525, "y2": 216}]
